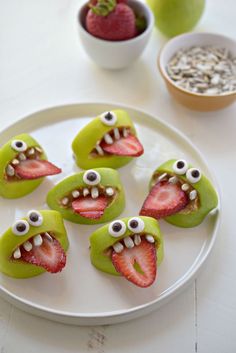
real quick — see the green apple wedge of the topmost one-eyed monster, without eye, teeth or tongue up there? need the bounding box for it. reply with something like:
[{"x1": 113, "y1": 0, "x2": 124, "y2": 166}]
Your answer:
[{"x1": 72, "y1": 110, "x2": 136, "y2": 169}]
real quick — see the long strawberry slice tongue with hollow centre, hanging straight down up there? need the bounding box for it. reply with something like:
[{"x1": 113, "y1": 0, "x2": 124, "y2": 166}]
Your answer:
[{"x1": 111, "y1": 239, "x2": 157, "y2": 288}]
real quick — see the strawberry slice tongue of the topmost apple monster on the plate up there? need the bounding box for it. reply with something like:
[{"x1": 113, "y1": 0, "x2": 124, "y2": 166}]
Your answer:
[{"x1": 101, "y1": 135, "x2": 144, "y2": 157}]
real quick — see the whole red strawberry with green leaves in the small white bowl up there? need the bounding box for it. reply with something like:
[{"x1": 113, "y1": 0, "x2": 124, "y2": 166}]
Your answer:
[{"x1": 86, "y1": 0, "x2": 138, "y2": 41}]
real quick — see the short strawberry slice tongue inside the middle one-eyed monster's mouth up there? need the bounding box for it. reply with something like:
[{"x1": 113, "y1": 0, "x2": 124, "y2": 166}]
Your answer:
[{"x1": 72, "y1": 196, "x2": 108, "y2": 219}]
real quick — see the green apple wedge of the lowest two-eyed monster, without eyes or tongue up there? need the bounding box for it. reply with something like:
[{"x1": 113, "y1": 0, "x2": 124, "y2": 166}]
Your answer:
[{"x1": 90, "y1": 217, "x2": 164, "y2": 276}]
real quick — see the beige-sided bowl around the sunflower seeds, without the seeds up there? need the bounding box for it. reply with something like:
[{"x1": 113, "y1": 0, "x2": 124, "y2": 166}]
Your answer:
[{"x1": 158, "y1": 33, "x2": 236, "y2": 111}]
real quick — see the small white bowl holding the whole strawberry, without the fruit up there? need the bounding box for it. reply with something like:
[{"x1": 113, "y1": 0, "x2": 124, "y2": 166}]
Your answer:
[{"x1": 78, "y1": 0, "x2": 154, "y2": 69}]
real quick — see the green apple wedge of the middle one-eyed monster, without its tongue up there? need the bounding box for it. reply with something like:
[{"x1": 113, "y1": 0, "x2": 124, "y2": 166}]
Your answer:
[{"x1": 47, "y1": 168, "x2": 125, "y2": 224}]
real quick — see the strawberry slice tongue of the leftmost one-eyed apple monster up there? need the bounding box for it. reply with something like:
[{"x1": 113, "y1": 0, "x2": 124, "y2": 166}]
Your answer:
[{"x1": 15, "y1": 159, "x2": 61, "y2": 179}]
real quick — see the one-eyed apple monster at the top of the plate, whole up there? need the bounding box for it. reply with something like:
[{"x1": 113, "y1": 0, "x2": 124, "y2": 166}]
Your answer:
[{"x1": 72, "y1": 110, "x2": 143, "y2": 169}]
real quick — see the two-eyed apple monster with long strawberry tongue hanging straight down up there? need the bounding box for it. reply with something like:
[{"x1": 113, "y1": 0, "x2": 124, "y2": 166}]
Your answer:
[{"x1": 90, "y1": 217, "x2": 163, "y2": 288}]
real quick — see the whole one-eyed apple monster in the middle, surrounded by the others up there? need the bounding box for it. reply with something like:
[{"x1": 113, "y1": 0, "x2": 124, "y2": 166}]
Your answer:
[{"x1": 47, "y1": 168, "x2": 125, "y2": 224}]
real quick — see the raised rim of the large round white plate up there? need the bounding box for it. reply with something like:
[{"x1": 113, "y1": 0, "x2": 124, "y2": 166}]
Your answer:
[{"x1": 0, "y1": 101, "x2": 221, "y2": 326}]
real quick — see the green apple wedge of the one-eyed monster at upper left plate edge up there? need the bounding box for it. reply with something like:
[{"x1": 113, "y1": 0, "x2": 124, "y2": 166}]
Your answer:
[{"x1": 0, "y1": 134, "x2": 47, "y2": 199}]
